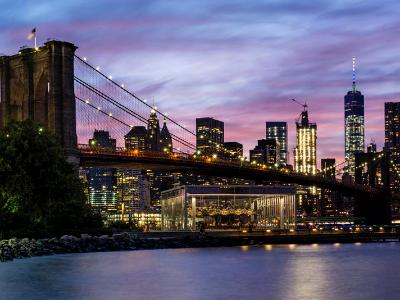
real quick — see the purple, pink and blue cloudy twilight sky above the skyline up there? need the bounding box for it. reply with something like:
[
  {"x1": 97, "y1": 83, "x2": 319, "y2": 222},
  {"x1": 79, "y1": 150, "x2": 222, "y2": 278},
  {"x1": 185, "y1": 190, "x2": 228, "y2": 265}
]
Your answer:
[{"x1": 0, "y1": 0, "x2": 400, "y2": 161}]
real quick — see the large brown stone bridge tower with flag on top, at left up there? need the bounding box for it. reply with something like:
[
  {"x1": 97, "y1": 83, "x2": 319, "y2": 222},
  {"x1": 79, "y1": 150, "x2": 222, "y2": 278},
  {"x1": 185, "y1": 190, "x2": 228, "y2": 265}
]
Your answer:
[{"x1": 0, "y1": 41, "x2": 77, "y2": 163}]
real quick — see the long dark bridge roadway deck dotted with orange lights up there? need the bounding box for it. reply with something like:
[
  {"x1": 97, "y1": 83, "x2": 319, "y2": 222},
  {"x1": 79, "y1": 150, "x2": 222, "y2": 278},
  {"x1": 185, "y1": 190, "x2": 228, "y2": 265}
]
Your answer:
[{"x1": 78, "y1": 144, "x2": 382, "y2": 197}]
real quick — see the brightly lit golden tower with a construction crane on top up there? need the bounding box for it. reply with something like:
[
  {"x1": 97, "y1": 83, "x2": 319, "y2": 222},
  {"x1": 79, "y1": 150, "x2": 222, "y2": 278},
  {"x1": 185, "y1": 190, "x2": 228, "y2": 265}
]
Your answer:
[{"x1": 294, "y1": 110, "x2": 317, "y2": 175}]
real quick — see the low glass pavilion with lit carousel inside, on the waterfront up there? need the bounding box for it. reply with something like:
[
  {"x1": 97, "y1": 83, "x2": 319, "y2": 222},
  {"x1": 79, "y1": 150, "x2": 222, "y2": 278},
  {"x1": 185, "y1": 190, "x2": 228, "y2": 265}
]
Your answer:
[{"x1": 161, "y1": 185, "x2": 296, "y2": 231}]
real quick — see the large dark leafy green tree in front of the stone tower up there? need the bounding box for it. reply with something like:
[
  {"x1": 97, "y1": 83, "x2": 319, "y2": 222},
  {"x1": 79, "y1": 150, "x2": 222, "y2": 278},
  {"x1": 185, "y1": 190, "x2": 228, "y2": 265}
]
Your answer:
[{"x1": 0, "y1": 120, "x2": 102, "y2": 236}]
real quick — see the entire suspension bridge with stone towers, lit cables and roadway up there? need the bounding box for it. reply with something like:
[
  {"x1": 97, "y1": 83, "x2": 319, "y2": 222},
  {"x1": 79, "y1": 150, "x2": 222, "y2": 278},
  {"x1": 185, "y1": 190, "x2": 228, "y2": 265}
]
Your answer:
[{"x1": 0, "y1": 40, "x2": 391, "y2": 224}]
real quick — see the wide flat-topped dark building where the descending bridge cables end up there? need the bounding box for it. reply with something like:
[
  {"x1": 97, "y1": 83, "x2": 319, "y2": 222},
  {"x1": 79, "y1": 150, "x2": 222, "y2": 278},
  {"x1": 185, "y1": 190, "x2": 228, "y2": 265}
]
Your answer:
[{"x1": 196, "y1": 118, "x2": 224, "y2": 155}]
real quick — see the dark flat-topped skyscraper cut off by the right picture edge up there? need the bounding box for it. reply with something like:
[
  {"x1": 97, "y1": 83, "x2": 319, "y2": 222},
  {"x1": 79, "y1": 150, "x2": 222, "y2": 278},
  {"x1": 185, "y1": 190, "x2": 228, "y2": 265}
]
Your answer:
[{"x1": 385, "y1": 102, "x2": 400, "y2": 192}]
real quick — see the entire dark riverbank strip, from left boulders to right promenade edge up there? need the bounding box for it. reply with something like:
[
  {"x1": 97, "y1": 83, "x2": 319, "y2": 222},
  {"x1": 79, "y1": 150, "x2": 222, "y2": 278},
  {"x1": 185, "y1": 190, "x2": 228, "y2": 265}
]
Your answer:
[{"x1": 0, "y1": 232, "x2": 400, "y2": 261}]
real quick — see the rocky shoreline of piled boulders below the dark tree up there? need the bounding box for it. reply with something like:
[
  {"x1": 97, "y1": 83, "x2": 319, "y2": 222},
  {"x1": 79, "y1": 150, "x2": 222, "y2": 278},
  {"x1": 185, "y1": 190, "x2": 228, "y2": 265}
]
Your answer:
[{"x1": 0, "y1": 232, "x2": 227, "y2": 262}]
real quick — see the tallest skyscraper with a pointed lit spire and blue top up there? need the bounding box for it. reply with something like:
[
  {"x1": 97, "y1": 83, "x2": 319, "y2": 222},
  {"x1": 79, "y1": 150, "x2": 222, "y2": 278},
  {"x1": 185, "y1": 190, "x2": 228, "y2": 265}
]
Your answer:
[{"x1": 344, "y1": 57, "x2": 365, "y2": 176}]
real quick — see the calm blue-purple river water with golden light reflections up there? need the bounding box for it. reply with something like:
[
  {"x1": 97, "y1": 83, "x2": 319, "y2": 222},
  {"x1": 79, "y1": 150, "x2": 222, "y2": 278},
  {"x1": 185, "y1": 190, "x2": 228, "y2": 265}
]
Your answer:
[{"x1": 0, "y1": 243, "x2": 400, "y2": 300}]
